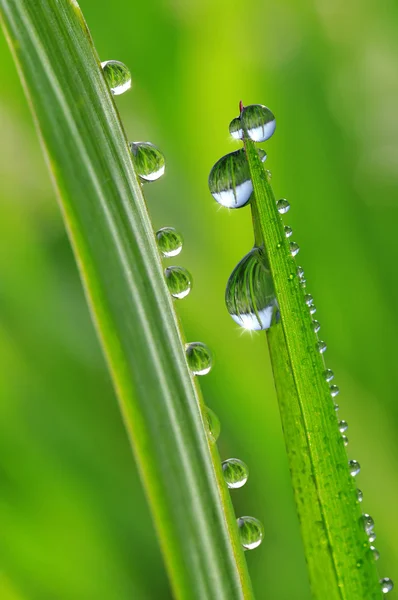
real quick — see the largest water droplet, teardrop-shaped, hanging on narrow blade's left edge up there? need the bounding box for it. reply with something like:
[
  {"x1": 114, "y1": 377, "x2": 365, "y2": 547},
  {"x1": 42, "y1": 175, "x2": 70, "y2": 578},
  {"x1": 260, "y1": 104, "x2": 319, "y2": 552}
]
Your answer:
[{"x1": 225, "y1": 247, "x2": 276, "y2": 331}]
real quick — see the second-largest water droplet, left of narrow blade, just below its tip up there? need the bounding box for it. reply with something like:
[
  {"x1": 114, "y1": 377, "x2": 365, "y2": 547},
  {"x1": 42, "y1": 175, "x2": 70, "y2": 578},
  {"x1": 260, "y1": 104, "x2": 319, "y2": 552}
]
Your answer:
[{"x1": 209, "y1": 148, "x2": 253, "y2": 208}]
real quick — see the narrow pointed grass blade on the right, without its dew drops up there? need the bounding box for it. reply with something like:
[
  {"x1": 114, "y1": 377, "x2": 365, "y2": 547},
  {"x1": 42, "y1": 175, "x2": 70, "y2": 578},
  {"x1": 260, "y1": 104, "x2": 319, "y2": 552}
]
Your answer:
[{"x1": 244, "y1": 139, "x2": 382, "y2": 600}]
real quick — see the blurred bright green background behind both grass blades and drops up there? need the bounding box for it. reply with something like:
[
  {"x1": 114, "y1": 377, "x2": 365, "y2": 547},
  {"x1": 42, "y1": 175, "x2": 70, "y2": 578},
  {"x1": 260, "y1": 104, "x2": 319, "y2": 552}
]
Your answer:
[{"x1": 0, "y1": 0, "x2": 398, "y2": 600}]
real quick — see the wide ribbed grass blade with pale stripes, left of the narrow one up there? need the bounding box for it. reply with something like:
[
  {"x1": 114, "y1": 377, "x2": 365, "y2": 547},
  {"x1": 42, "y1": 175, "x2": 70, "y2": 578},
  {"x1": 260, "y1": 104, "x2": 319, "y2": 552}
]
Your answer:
[{"x1": 0, "y1": 0, "x2": 252, "y2": 600}]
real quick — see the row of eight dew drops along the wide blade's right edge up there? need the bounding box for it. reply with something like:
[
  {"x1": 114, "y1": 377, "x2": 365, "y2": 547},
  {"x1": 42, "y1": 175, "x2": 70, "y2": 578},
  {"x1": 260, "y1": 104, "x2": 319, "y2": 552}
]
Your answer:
[{"x1": 101, "y1": 60, "x2": 264, "y2": 550}]
